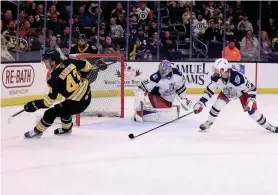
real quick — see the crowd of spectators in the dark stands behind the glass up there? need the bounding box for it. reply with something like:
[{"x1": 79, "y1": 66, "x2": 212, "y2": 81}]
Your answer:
[{"x1": 1, "y1": 0, "x2": 278, "y2": 61}]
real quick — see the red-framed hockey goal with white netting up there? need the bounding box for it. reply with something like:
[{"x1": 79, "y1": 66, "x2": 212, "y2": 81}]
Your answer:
[{"x1": 76, "y1": 53, "x2": 125, "y2": 126}]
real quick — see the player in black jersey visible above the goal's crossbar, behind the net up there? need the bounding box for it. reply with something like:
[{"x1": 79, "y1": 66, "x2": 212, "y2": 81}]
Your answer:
[{"x1": 70, "y1": 34, "x2": 98, "y2": 54}]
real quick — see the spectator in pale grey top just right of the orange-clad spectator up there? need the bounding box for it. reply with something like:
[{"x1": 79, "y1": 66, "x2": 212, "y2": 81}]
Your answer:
[{"x1": 240, "y1": 38, "x2": 258, "y2": 61}]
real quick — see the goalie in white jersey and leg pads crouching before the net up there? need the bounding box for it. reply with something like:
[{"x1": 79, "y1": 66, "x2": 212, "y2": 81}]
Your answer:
[{"x1": 134, "y1": 60, "x2": 192, "y2": 122}]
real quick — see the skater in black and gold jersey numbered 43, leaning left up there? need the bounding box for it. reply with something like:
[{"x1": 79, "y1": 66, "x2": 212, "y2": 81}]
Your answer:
[{"x1": 24, "y1": 50, "x2": 94, "y2": 138}]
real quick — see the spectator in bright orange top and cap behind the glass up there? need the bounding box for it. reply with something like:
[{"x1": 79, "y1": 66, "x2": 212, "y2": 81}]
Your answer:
[{"x1": 222, "y1": 39, "x2": 241, "y2": 62}]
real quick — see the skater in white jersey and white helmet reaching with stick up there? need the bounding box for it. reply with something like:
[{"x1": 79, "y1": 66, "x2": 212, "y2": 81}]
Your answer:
[{"x1": 193, "y1": 58, "x2": 278, "y2": 133}]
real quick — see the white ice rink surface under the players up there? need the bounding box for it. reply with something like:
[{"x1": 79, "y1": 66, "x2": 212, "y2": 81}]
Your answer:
[{"x1": 1, "y1": 95, "x2": 278, "y2": 195}]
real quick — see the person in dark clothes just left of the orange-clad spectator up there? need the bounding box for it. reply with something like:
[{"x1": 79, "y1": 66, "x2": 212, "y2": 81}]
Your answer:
[{"x1": 205, "y1": 22, "x2": 221, "y2": 58}]
